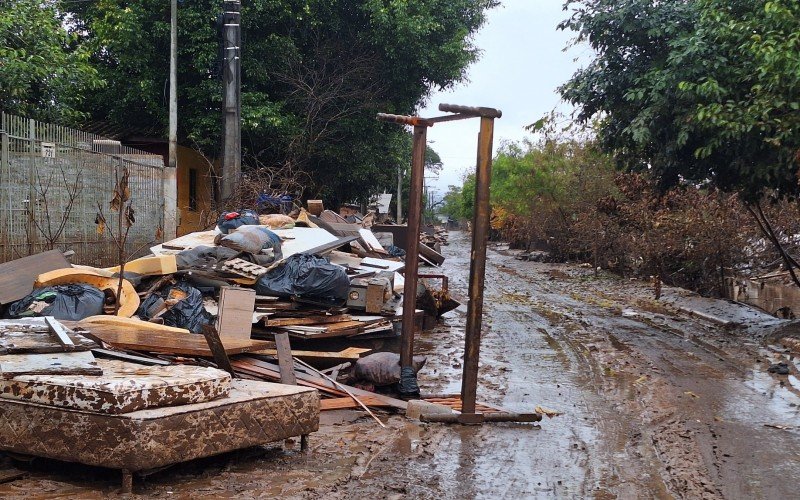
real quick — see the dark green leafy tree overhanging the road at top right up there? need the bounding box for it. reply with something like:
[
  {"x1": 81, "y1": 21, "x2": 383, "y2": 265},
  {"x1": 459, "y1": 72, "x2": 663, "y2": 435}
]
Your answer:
[{"x1": 560, "y1": 0, "x2": 800, "y2": 199}]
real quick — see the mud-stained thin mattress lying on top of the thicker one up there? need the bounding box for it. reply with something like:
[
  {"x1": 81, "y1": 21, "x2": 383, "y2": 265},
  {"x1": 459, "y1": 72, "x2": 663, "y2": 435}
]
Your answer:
[{"x1": 0, "y1": 359, "x2": 231, "y2": 414}]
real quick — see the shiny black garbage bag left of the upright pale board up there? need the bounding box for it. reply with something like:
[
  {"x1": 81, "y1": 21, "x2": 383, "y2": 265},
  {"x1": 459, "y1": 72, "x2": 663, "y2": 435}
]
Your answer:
[{"x1": 136, "y1": 283, "x2": 213, "y2": 333}]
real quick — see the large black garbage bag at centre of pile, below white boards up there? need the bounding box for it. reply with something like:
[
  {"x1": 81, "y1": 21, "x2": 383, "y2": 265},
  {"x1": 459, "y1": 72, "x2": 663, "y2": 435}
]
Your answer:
[{"x1": 256, "y1": 253, "x2": 350, "y2": 301}]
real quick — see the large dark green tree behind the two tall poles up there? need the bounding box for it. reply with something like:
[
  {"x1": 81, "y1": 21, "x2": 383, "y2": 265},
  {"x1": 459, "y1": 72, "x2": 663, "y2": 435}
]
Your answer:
[{"x1": 70, "y1": 0, "x2": 497, "y2": 204}]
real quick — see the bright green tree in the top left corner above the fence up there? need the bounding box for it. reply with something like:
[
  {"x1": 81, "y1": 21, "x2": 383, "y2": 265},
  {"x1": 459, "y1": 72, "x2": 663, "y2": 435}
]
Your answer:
[{"x1": 0, "y1": 0, "x2": 103, "y2": 123}]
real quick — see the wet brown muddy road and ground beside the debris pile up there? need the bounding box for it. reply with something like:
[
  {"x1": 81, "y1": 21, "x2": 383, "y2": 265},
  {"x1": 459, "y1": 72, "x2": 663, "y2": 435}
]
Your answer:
[{"x1": 0, "y1": 232, "x2": 800, "y2": 499}]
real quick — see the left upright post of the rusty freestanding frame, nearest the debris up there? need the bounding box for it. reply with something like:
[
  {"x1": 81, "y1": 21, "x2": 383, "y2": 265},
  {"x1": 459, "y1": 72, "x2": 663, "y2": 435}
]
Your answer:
[{"x1": 400, "y1": 125, "x2": 428, "y2": 396}]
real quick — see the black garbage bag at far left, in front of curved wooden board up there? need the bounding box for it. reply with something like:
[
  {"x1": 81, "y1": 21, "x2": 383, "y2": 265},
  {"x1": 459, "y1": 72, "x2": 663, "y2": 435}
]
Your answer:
[{"x1": 6, "y1": 283, "x2": 105, "y2": 321}]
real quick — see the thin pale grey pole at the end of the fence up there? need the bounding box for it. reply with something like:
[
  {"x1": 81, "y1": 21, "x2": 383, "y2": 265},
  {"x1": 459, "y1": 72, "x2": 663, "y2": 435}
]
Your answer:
[{"x1": 163, "y1": 0, "x2": 178, "y2": 240}]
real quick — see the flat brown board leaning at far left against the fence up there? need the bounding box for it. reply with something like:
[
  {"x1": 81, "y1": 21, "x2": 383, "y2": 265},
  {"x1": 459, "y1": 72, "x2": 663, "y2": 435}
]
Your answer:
[{"x1": 0, "y1": 250, "x2": 72, "y2": 304}]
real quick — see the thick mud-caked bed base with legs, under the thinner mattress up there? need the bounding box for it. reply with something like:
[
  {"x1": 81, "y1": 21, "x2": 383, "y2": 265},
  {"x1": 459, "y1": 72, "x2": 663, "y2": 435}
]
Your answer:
[{"x1": 0, "y1": 380, "x2": 319, "y2": 472}]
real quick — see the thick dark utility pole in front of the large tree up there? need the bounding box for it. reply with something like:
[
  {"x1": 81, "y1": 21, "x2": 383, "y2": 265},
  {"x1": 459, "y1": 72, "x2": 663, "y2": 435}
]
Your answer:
[{"x1": 220, "y1": 0, "x2": 242, "y2": 201}]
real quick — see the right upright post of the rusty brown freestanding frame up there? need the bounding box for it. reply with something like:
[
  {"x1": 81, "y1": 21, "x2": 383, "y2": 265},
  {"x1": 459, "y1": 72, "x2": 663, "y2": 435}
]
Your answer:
[{"x1": 461, "y1": 117, "x2": 494, "y2": 415}]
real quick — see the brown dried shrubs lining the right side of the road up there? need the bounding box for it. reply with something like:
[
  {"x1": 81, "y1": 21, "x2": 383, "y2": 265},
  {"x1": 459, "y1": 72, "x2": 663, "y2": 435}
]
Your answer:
[{"x1": 504, "y1": 173, "x2": 759, "y2": 295}]
